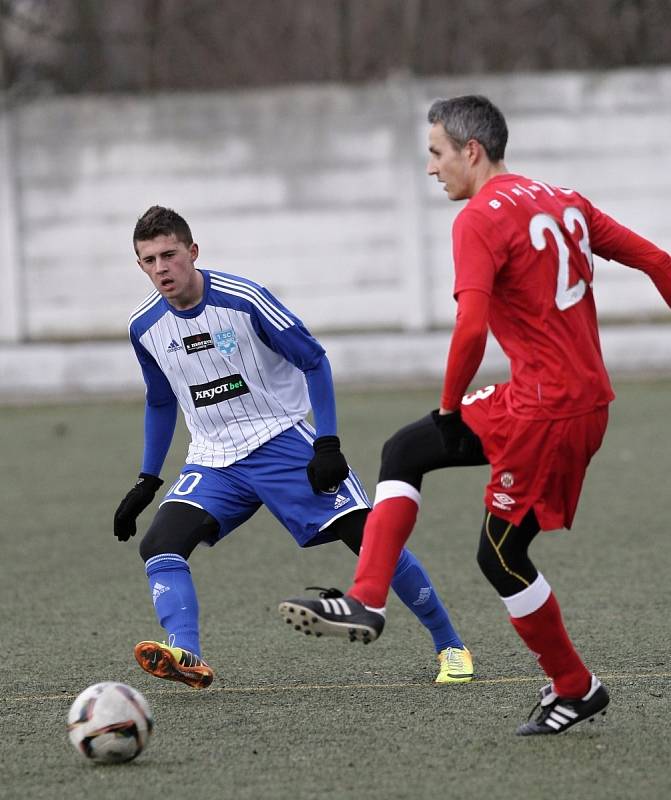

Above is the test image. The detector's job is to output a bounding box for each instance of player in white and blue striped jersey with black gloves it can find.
[114,206,468,688]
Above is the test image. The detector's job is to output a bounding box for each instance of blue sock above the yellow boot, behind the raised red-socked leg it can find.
[391,548,464,653]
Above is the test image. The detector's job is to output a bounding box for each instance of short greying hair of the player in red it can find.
[428,94,508,161]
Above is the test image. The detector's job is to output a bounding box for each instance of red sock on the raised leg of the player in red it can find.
[347,497,419,608]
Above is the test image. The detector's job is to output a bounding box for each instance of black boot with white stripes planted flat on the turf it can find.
[517,675,610,736]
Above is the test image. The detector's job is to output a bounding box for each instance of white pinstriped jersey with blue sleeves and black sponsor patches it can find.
[129,269,324,467]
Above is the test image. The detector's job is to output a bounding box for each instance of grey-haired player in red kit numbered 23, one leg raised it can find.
[280,96,671,736]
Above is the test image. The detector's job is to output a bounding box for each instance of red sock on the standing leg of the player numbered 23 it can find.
[510,593,592,697]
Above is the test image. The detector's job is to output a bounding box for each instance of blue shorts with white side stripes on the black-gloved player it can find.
[161,422,370,547]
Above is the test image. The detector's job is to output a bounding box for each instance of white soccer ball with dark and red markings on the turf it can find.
[67,681,154,764]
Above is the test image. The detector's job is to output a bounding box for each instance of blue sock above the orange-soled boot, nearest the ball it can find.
[145,553,200,656]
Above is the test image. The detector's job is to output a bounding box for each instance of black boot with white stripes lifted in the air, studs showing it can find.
[279,586,384,644]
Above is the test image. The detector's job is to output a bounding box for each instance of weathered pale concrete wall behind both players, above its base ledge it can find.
[0,69,671,394]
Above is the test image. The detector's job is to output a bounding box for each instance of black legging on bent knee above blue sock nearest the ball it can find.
[139,503,219,561]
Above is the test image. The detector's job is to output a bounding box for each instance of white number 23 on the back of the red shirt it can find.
[529,206,594,311]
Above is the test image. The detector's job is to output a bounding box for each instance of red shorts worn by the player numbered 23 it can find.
[461,383,608,531]
